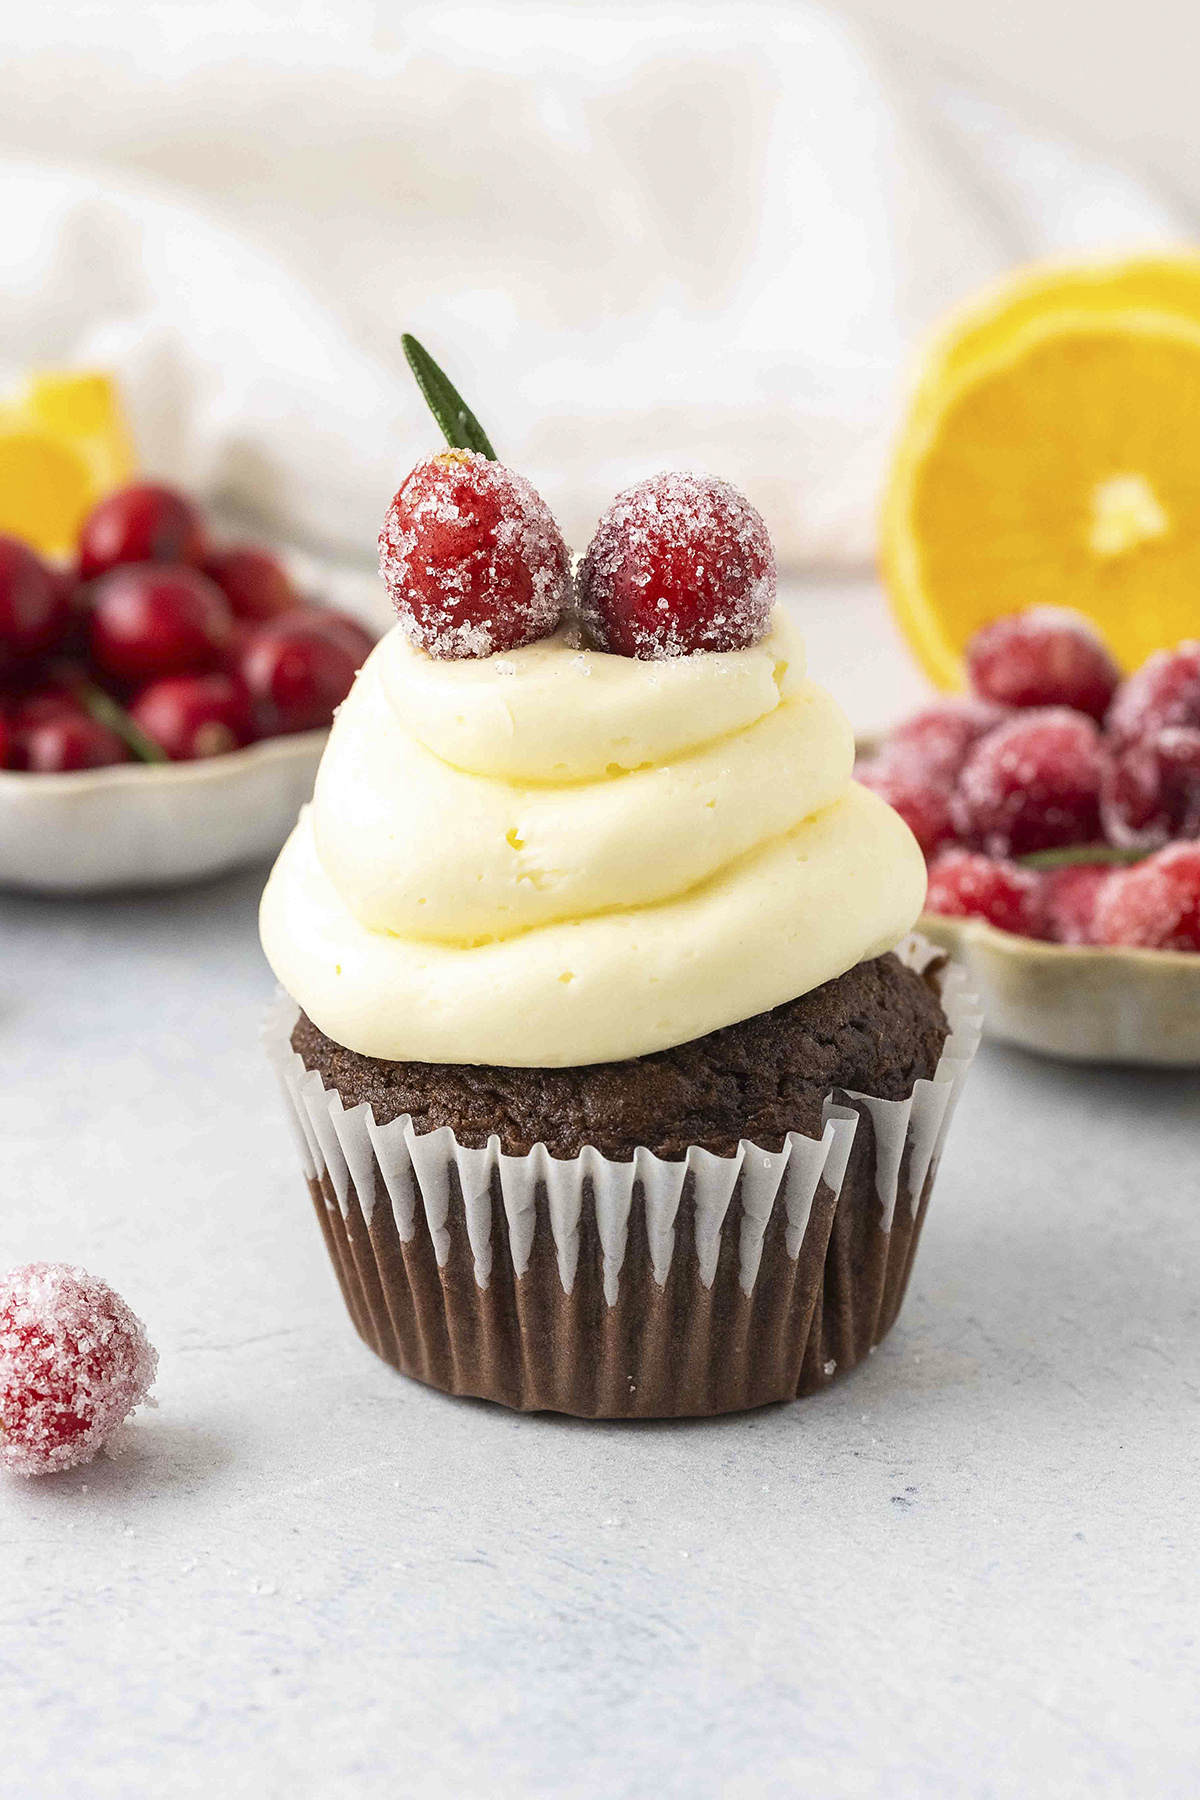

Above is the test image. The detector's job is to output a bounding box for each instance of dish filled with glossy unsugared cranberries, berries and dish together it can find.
[0,481,376,893]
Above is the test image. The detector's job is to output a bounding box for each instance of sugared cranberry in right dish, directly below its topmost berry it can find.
[950,706,1106,857]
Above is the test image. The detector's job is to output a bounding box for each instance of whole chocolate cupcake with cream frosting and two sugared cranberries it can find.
[261,354,979,1417]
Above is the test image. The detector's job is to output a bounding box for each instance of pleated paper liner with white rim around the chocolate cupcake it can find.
[264,936,981,1418]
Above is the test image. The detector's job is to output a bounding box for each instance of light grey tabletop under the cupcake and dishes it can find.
[0,583,1200,1800]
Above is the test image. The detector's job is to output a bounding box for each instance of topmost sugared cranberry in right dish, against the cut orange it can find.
[966,607,1121,718]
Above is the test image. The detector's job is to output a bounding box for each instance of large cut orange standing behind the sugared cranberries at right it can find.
[882,256,1200,688]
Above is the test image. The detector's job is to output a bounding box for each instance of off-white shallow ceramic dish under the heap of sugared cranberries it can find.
[918,913,1200,1067]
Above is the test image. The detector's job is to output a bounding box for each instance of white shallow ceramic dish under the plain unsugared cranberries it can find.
[0,538,392,893]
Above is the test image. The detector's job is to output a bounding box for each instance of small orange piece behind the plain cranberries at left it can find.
[0,373,137,556]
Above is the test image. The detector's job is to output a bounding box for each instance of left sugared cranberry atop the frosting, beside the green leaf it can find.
[380,450,570,659]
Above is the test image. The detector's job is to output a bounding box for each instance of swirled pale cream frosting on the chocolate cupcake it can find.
[261,608,925,1067]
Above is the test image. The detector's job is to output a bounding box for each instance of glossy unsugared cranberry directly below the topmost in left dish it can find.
[88,565,232,682]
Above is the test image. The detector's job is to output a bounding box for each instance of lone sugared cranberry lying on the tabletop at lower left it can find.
[0,1262,158,1474]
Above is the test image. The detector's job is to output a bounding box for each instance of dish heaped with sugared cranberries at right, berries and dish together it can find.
[856,607,1200,1066]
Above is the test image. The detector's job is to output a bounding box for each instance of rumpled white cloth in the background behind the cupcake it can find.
[0,0,1187,565]
